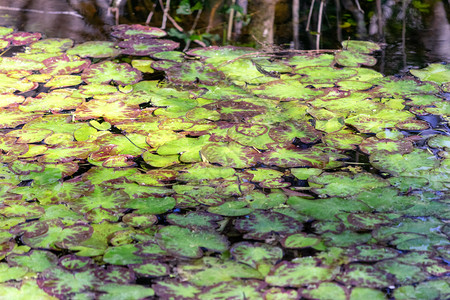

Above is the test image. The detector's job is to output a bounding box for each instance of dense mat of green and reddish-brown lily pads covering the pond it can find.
[0,25,450,299]
